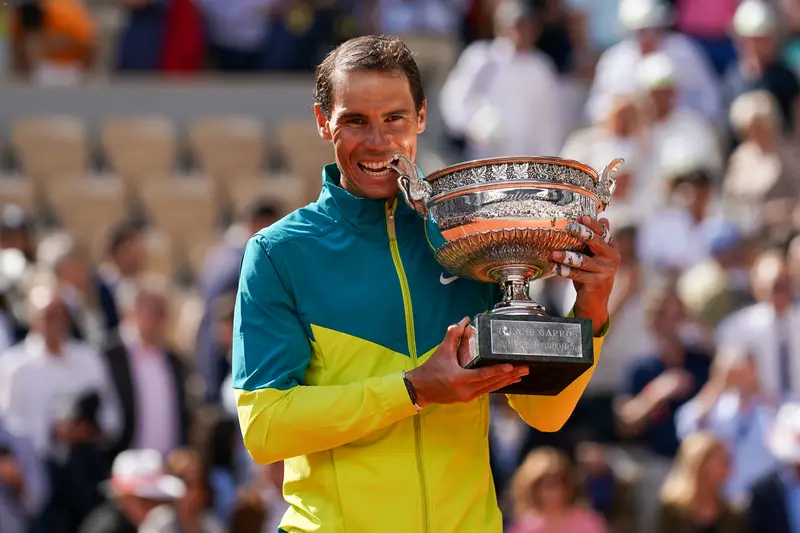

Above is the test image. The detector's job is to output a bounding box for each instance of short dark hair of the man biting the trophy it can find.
[314,35,425,117]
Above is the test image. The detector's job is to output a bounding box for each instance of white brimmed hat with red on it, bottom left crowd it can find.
[102,450,186,501]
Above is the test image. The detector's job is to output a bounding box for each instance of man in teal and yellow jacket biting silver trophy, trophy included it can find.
[232,32,620,533]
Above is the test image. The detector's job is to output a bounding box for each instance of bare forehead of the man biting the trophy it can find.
[332,71,414,114]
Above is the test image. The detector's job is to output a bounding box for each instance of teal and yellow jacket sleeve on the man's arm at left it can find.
[232,236,416,464]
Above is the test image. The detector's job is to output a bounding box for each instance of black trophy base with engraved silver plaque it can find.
[466,311,594,396]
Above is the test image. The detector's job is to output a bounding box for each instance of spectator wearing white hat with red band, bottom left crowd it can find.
[79,450,186,533]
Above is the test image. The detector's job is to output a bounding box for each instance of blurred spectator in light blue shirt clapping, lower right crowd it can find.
[675,346,778,505]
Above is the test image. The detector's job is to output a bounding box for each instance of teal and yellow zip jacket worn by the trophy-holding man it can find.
[233,165,602,533]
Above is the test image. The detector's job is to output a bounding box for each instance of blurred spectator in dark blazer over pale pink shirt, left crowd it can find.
[105,277,190,456]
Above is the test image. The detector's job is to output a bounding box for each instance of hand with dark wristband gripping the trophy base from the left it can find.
[406,318,529,407]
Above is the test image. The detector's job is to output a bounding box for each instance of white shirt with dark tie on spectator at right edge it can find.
[717,303,800,397]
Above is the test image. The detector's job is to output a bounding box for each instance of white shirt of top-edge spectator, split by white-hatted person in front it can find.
[586,33,723,124]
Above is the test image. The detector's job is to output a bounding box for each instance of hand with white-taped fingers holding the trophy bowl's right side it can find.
[550,216,620,335]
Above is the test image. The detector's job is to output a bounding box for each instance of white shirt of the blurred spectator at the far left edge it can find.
[0,334,120,455]
